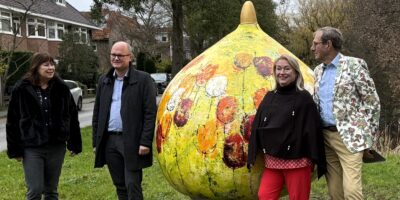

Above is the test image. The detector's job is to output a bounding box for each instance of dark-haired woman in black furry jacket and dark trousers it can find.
[6,53,82,199]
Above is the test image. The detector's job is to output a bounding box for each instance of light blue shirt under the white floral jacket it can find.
[319,54,339,126]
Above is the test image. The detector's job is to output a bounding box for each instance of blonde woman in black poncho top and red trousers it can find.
[248,55,326,200]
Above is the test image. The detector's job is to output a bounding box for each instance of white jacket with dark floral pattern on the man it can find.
[314,54,380,153]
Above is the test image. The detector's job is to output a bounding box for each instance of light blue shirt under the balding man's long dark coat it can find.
[108,71,128,132]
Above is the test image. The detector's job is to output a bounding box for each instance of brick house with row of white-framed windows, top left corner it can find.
[0,0,100,58]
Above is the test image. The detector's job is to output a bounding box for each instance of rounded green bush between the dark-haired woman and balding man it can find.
[58,34,98,87]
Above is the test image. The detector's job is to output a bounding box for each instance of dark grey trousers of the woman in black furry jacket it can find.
[22,143,66,200]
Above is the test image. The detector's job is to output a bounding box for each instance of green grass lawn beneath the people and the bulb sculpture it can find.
[0,128,400,200]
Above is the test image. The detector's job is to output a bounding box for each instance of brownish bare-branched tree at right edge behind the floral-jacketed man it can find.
[344,0,400,126]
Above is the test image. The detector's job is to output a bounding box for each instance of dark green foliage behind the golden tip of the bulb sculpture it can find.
[184,0,277,55]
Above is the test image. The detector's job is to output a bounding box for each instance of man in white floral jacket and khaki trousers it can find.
[311,27,380,200]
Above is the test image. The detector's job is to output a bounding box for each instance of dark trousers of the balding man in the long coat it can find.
[105,135,143,200]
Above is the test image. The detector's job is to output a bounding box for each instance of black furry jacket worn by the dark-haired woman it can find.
[6,77,82,158]
